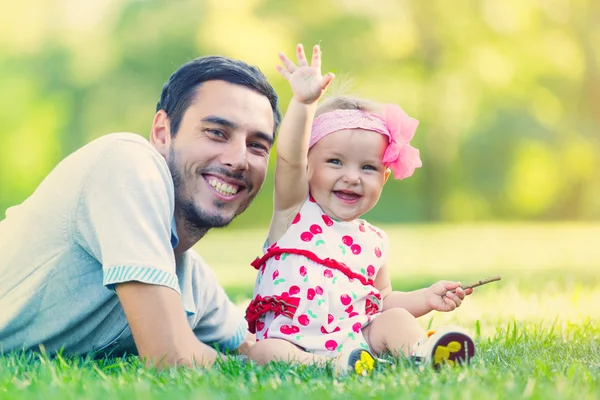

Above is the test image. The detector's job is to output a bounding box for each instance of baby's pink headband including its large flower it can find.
[309,104,422,179]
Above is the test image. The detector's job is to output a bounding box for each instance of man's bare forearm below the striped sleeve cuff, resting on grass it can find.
[116,282,217,368]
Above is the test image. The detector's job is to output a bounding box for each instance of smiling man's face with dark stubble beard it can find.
[166,81,274,229]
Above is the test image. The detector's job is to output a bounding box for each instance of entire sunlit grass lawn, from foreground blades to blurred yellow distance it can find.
[0,225,600,399]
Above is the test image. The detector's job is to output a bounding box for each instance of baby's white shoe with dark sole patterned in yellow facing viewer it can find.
[412,326,475,369]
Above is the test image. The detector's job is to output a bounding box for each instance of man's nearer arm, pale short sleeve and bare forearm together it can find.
[73,139,209,366]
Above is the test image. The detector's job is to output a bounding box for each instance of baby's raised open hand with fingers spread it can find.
[277,44,334,104]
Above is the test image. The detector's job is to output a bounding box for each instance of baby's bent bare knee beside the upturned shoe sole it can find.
[362,308,426,357]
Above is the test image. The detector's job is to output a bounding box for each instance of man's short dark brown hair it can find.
[156,56,281,136]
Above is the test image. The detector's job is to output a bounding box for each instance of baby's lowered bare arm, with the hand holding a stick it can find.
[375,266,473,318]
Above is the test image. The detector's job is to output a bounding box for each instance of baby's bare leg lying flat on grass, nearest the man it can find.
[248,339,332,367]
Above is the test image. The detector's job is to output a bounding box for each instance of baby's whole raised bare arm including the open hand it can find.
[269,44,333,243]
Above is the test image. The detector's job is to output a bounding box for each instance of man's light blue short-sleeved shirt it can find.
[0,133,247,354]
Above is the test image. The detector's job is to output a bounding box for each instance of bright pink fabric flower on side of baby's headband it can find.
[383,104,423,179]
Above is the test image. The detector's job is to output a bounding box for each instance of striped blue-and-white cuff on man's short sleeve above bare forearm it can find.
[103,265,180,293]
